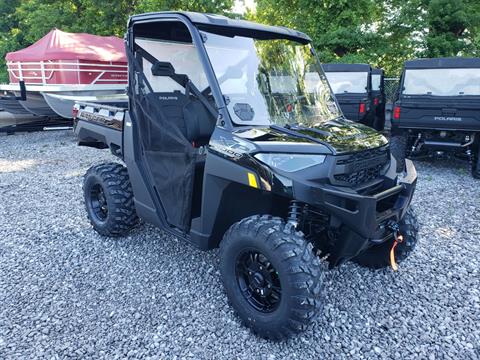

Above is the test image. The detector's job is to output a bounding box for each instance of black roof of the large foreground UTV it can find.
[128,11,312,44]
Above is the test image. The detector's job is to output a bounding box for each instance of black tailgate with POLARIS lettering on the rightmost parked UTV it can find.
[392,97,480,131]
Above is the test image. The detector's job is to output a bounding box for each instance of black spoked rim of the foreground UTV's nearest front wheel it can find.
[235,250,282,313]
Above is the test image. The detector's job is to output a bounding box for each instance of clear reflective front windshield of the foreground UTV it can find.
[205,33,341,126]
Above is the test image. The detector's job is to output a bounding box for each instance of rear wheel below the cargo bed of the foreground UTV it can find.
[83,163,138,236]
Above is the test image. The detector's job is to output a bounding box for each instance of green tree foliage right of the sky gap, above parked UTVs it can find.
[248,0,480,76]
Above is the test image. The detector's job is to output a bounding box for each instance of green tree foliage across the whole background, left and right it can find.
[0,0,480,82]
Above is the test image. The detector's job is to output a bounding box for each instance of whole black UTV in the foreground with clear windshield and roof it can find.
[74,12,418,339]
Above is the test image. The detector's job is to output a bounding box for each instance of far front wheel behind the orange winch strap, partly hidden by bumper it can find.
[352,208,419,269]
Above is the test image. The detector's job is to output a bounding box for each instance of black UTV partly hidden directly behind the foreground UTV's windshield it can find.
[322,64,375,127]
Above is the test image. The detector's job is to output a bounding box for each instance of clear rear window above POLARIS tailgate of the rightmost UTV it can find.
[402,69,480,96]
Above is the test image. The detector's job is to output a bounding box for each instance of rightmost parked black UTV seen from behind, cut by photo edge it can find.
[391,57,480,178]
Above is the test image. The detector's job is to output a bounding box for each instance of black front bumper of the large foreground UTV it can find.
[294,160,417,261]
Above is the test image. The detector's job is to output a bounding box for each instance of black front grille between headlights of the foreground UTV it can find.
[334,146,390,186]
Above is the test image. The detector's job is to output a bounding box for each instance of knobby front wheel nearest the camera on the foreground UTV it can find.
[220,216,323,340]
